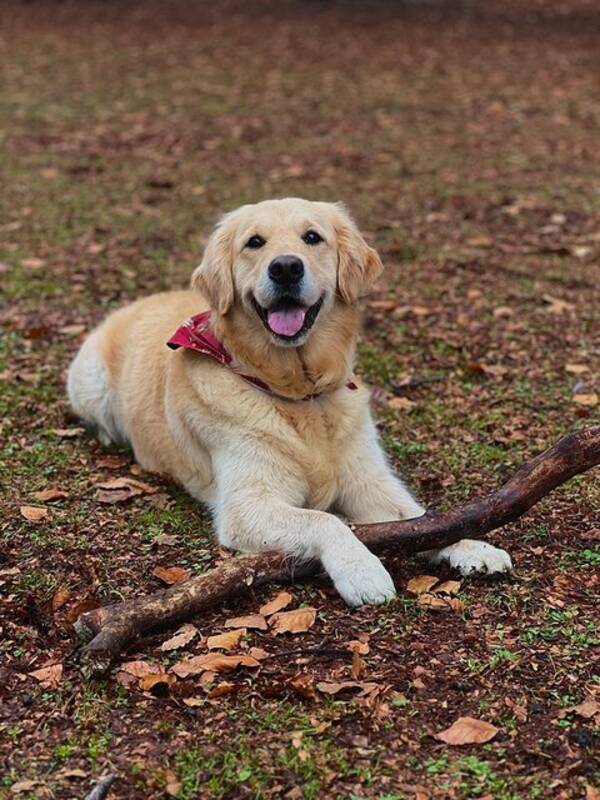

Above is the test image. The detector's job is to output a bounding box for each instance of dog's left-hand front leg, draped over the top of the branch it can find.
[213,444,395,606]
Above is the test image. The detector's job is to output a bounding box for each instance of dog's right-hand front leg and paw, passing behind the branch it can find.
[337,420,513,575]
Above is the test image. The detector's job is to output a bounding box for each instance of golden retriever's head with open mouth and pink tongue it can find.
[192,198,382,347]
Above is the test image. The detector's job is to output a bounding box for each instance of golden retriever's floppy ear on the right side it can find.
[334,203,383,305]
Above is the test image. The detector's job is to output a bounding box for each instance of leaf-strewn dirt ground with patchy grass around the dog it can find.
[0,0,600,800]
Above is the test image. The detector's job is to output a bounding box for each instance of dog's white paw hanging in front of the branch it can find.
[321,542,396,606]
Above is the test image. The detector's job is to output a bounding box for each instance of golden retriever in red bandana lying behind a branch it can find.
[68,198,512,606]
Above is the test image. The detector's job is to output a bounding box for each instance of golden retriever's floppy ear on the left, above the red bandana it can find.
[191,217,234,315]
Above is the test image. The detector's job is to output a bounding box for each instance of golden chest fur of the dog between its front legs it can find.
[279,401,358,509]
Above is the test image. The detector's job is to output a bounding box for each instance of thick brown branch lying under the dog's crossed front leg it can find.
[75,427,600,673]
